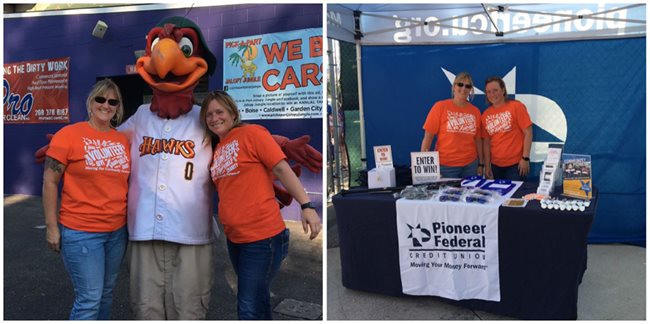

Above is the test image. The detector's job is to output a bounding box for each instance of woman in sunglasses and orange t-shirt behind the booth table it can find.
[420,72,483,178]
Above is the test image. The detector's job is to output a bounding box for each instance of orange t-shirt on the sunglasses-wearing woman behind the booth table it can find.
[422,99,481,167]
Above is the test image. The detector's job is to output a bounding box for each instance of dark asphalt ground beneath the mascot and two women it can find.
[4,195,323,320]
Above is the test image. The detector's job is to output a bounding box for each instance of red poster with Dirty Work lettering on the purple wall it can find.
[2,57,70,124]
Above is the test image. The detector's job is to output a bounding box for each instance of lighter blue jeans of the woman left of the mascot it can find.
[59,224,127,320]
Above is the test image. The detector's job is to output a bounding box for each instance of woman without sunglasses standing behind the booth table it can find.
[482,77,533,181]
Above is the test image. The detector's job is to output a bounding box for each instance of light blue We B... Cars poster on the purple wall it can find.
[223,28,323,120]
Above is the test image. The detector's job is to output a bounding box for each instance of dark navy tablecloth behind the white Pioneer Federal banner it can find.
[332,183,598,319]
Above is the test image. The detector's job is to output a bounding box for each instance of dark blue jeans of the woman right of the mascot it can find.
[228,229,289,320]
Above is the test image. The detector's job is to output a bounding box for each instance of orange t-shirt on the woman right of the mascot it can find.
[210,125,286,243]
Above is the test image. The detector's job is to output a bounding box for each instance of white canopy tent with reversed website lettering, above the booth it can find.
[327,3,646,169]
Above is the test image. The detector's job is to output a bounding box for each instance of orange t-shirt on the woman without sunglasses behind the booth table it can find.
[482,100,533,167]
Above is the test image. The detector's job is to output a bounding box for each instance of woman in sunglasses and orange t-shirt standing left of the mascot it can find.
[43,79,131,320]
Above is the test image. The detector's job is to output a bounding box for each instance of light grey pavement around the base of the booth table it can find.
[327,204,646,320]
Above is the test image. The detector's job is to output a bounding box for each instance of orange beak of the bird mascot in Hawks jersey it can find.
[135,38,208,92]
